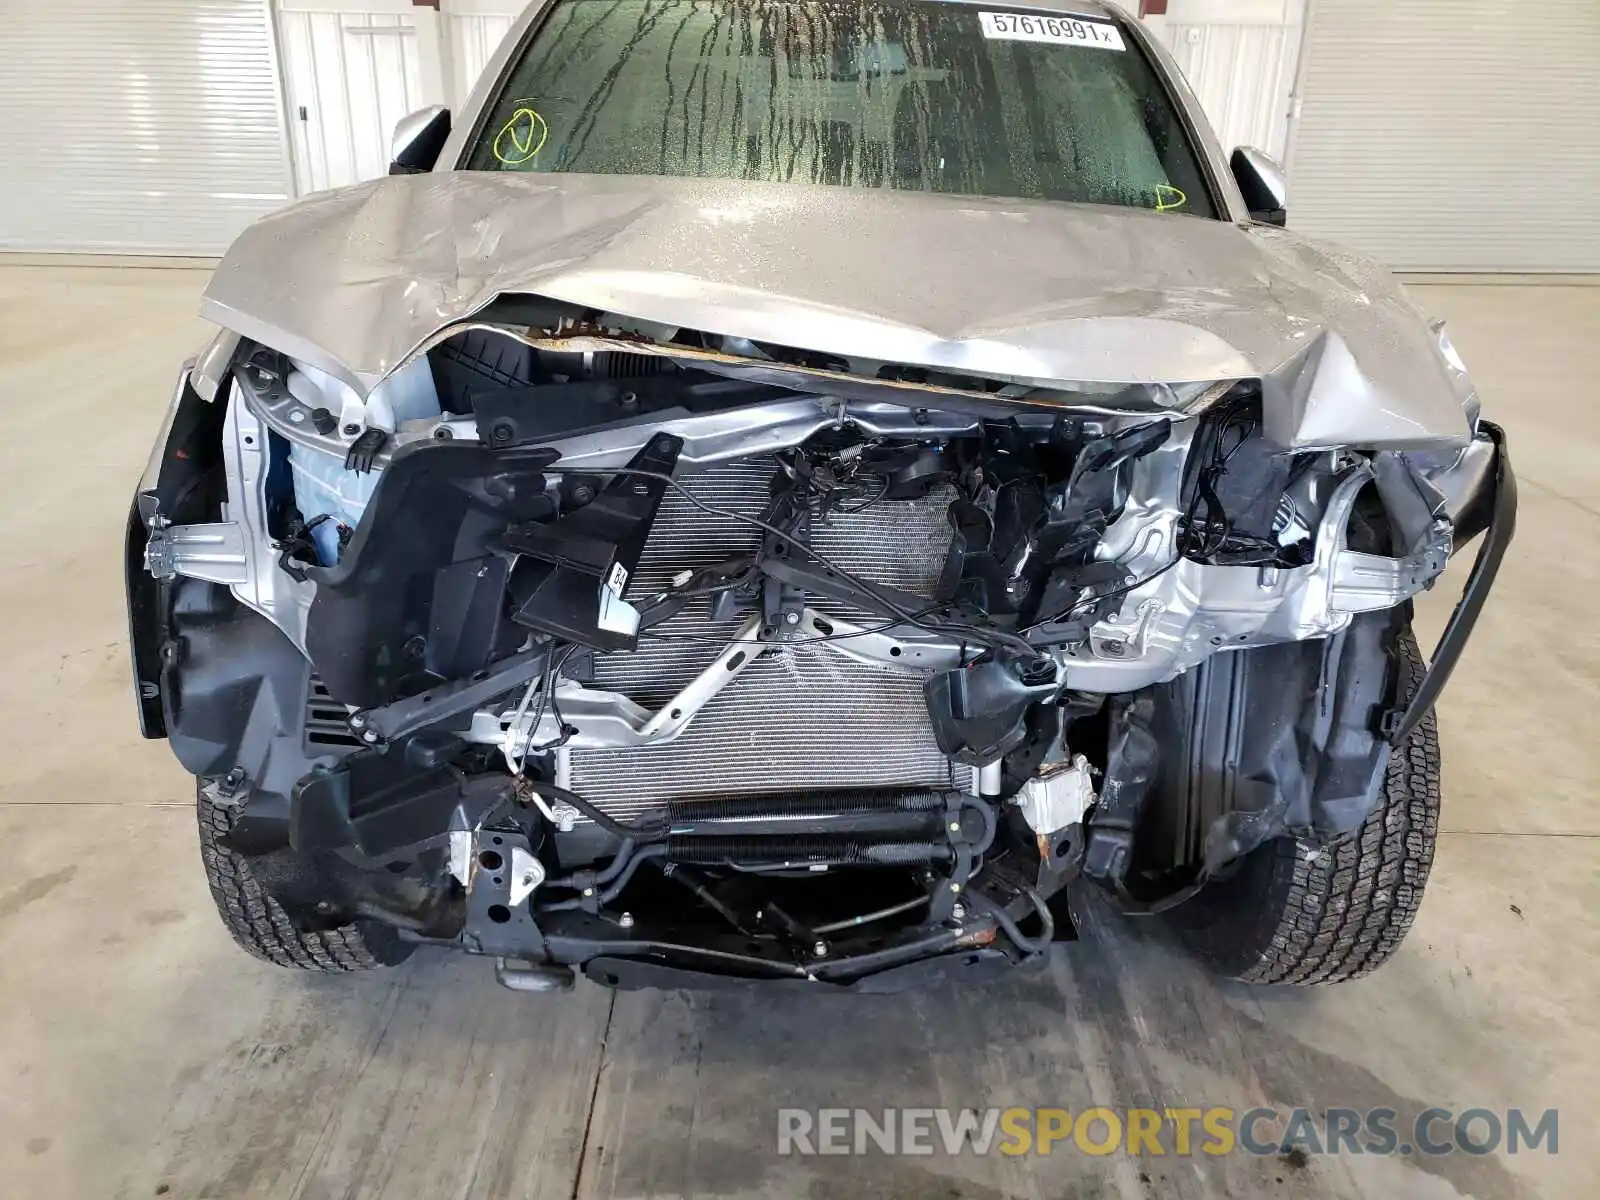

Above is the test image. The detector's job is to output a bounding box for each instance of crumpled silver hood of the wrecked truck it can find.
[202,171,1470,446]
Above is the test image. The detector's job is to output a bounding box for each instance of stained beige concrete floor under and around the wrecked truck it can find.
[0,267,1600,1200]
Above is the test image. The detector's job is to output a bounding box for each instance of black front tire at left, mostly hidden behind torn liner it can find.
[195,790,414,971]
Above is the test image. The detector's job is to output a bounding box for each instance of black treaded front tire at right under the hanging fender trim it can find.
[1170,626,1440,986]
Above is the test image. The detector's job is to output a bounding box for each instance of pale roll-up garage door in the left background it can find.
[0,0,291,254]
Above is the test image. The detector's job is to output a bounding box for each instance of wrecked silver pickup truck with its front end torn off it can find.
[126,0,1515,990]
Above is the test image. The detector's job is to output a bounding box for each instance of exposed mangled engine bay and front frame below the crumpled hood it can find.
[121,315,1497,987]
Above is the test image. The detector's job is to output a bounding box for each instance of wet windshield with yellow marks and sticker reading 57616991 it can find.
[467,0,1214,216]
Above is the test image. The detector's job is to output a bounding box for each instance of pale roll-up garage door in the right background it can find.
[1290,0,1600,272]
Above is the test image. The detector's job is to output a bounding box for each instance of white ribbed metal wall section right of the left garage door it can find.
[278,0,424,194]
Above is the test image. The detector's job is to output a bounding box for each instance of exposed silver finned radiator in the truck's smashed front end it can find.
[558,458,970,818]
